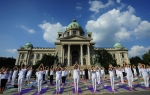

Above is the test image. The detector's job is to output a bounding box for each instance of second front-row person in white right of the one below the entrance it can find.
[108,64,115,92]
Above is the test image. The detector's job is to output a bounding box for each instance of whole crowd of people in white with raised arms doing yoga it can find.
[0,62,150,95]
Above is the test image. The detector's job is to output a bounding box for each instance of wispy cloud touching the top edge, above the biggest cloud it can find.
[88,0,114,13]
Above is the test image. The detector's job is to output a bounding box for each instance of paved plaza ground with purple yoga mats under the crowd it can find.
[3,75,150,95]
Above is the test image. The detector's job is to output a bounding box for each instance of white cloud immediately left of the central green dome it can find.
[38,21,66,43]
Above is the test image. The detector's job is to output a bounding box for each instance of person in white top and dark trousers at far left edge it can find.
[0,68,10,94]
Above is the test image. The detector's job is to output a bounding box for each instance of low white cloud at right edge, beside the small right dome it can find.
[129,45,150,57]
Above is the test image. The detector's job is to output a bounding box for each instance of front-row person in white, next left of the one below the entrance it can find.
[56,66,62,94]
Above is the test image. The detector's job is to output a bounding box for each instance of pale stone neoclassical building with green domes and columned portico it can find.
[16,20,130,66]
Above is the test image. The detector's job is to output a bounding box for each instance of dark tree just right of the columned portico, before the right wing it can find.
[97,49,117,73]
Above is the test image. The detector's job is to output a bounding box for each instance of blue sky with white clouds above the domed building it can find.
[0,0,150,58]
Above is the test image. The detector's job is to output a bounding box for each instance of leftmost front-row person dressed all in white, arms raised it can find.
[18,64,27,94]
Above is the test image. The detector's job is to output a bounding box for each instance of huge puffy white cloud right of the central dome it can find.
[85,6,150,46]
